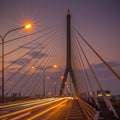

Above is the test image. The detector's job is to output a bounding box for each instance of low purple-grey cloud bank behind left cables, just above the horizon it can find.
[5,66,63,95]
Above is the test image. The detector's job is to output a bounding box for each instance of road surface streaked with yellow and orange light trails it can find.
[0,97,85,120]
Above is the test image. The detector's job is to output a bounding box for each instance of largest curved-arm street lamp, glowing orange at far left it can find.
[0,23,32,99]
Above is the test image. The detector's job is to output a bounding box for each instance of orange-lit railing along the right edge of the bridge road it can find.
[76,98,99,120]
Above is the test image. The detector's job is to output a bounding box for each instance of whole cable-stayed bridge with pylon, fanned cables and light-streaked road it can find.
[0,10,120,120]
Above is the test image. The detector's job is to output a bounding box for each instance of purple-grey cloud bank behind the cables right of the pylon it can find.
[75,61,120,81]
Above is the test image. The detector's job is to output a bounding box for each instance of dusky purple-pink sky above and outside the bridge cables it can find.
[0,0,120,94]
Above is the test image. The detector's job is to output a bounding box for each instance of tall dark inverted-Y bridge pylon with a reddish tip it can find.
[60,10,79,96]
